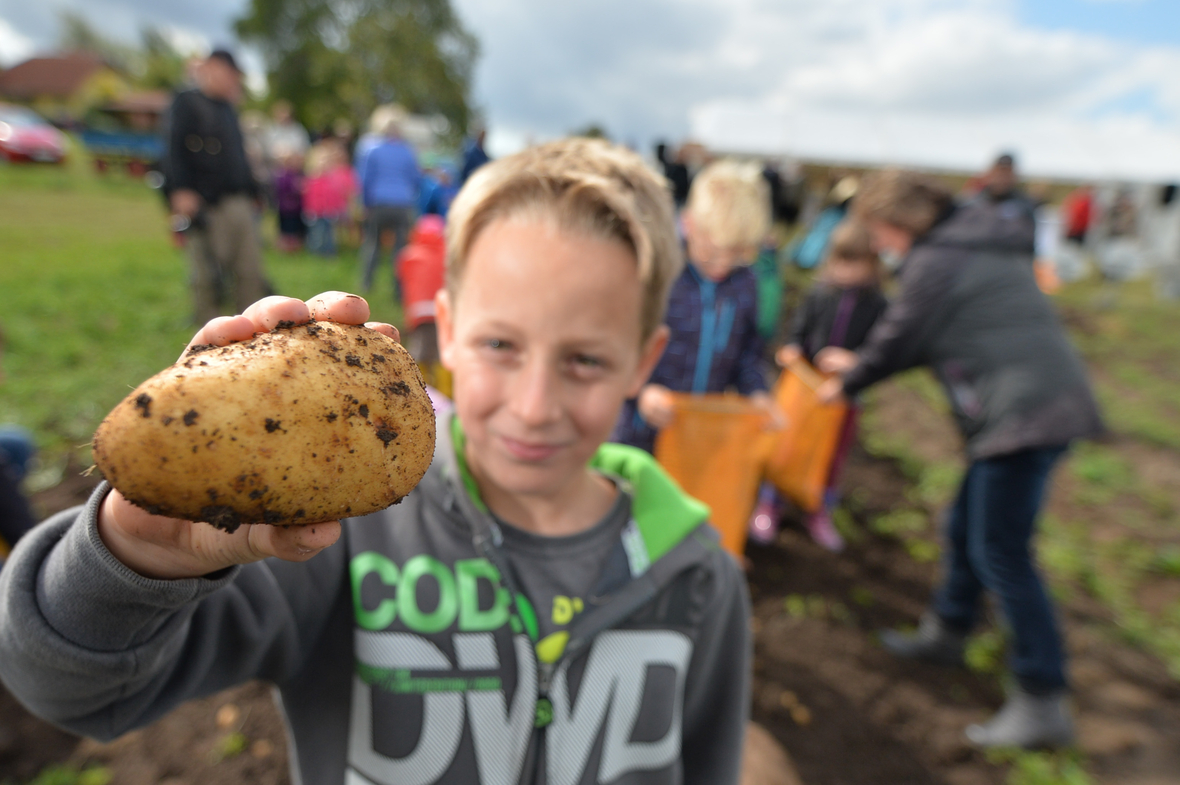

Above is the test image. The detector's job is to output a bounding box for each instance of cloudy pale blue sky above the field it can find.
[0,0,1180,182]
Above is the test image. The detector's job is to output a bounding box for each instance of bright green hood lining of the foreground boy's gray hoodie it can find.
[451,416,709,562]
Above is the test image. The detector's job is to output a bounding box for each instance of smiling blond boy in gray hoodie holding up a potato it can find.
[0,139,749,785]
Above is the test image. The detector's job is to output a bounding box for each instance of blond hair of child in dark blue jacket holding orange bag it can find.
[688,158,771,248]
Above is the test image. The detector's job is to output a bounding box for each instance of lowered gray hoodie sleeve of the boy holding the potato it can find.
[681,550,752,785]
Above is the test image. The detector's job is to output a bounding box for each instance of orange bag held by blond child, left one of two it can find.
[655,393,767,557]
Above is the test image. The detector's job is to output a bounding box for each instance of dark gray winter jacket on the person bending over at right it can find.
[844,199,1102,460]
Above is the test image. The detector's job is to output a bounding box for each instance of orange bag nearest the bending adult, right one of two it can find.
[765,360,848,512]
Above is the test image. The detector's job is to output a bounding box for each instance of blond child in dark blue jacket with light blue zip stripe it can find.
[614,161,771,452]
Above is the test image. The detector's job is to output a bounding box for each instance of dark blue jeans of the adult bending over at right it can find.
[933,446,1066,694]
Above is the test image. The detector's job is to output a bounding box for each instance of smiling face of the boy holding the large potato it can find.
[438,212,667,499]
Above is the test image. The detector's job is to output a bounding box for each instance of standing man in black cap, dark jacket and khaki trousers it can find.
[164,50,270,325]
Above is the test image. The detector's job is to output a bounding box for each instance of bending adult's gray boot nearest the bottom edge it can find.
[965,688,1074,750]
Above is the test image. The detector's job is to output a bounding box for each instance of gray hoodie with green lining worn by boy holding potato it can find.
[0,413,750,785]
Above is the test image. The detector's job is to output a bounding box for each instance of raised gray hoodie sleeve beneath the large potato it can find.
[0,485,345,739]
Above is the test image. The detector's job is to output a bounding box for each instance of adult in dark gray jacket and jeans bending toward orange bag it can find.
[818,171,1102,747]
